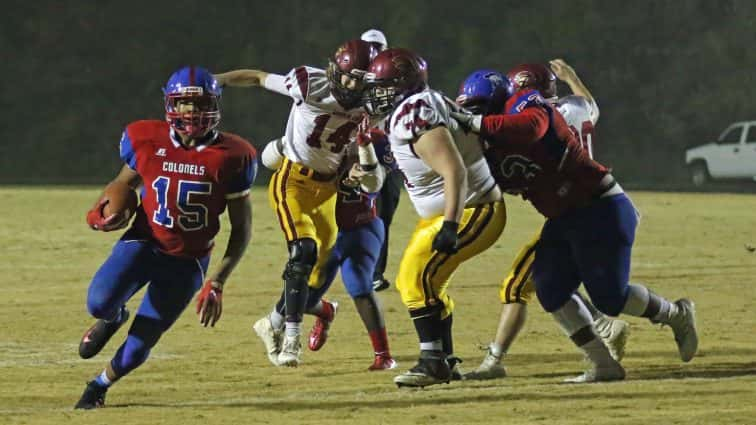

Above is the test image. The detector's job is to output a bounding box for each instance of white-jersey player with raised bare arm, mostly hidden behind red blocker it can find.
[457,59,629,379]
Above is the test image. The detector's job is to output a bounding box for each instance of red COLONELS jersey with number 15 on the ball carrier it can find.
[121,120,257,258]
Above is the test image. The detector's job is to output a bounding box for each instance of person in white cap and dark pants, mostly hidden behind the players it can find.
[360,29,402,291]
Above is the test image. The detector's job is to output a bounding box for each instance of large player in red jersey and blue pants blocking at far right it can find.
[453,68,698,383]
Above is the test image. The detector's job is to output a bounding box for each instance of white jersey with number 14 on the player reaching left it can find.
[283,66,362,174]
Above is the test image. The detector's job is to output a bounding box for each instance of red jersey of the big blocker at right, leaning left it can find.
[480,90,609,218]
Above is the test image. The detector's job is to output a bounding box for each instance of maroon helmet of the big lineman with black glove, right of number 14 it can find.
[364,48,428,115]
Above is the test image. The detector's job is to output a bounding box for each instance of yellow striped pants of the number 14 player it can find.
[268,158,338,288]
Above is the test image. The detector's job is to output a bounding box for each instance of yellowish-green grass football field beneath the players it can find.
[0,188,756,425]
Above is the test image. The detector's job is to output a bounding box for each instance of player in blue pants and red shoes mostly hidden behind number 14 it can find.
[262,115,397,370]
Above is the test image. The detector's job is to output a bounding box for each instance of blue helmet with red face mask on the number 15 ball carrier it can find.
[163,66,221,138]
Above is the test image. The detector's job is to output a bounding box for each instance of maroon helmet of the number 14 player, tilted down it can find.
[326,39,378,109]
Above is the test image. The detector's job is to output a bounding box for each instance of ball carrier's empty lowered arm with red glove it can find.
[197,196,252,326]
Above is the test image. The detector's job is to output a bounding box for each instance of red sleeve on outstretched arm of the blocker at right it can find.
[480,107,549,143]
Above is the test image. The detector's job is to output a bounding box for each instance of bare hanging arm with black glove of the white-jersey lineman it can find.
[413,126,467,254]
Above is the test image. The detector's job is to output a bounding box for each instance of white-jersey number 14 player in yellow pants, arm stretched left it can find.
[216,40,376,367]
